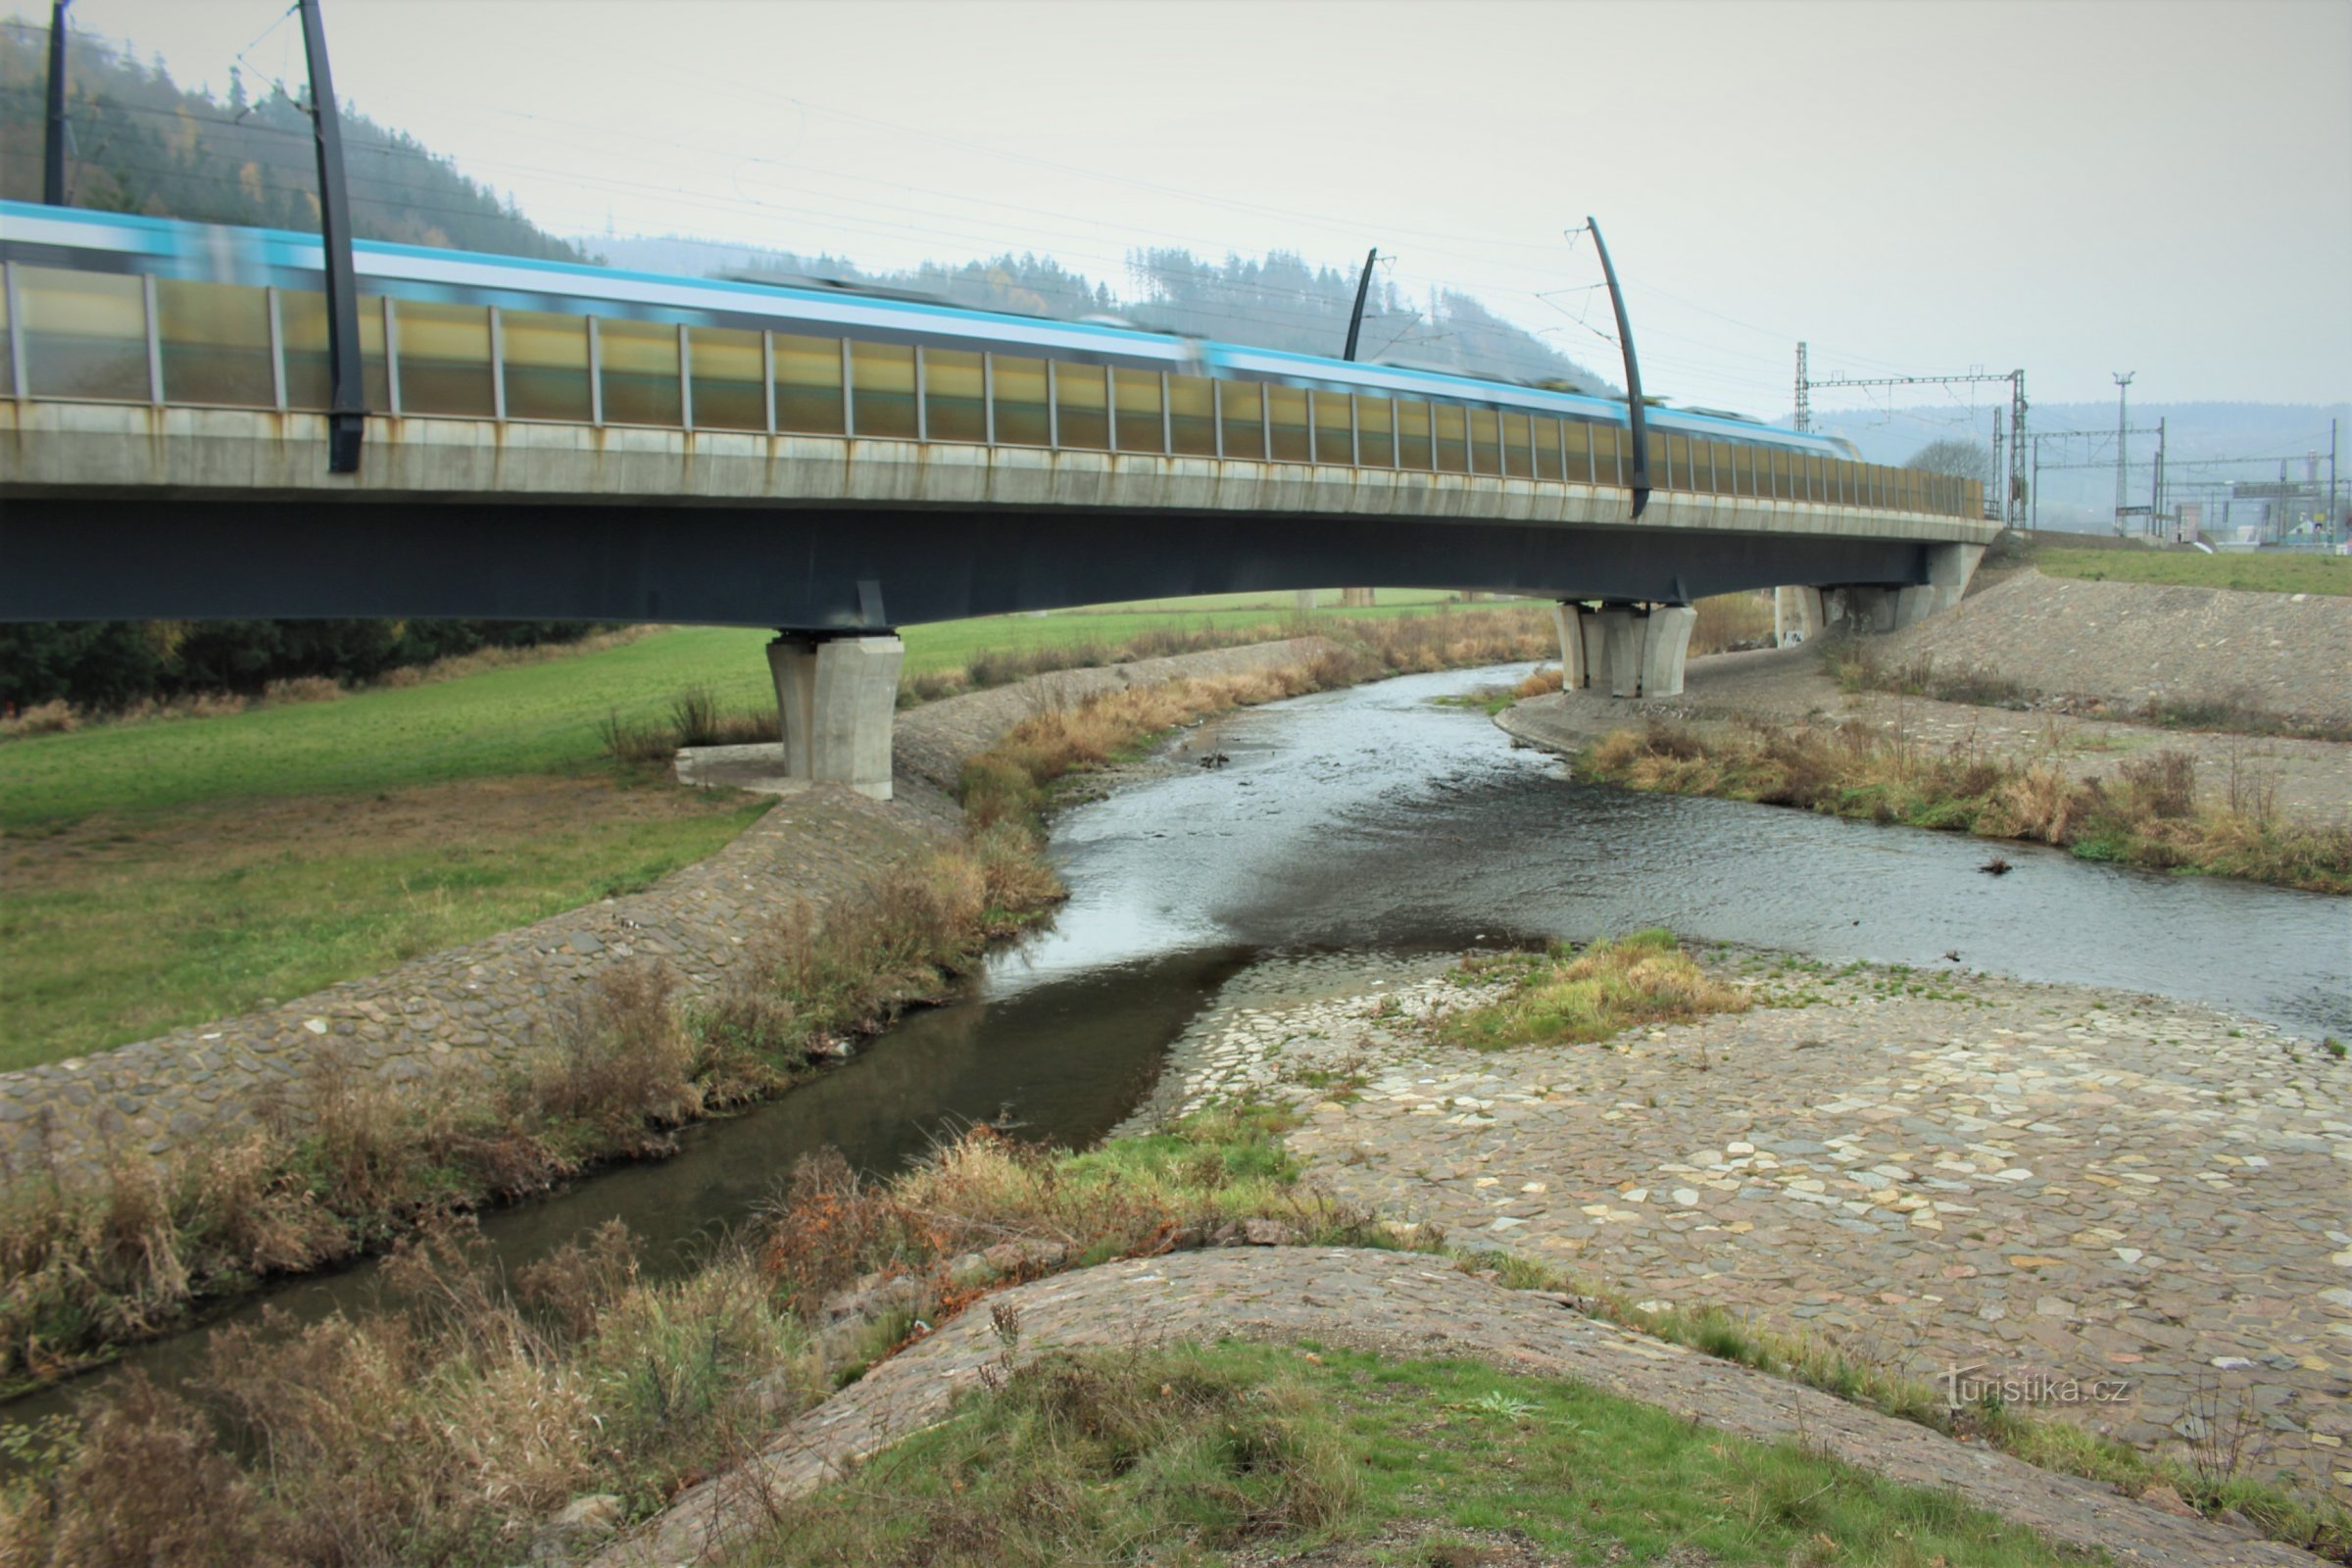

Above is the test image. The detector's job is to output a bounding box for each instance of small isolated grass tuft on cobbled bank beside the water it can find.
[1437,929,1747,1051]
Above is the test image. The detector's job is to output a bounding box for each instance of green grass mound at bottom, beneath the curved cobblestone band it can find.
[766,1340,2100,1568]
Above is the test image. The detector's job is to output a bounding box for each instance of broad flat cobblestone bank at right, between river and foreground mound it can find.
[1109,956,2352,1499]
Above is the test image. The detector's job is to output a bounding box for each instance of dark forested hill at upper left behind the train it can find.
[0,19,590,261]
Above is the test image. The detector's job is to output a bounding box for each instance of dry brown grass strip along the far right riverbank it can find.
[1578,721,2352,894]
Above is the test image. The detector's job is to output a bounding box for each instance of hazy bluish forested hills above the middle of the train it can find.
[593,235,1616,390]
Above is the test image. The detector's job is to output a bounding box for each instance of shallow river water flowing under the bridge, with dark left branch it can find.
[7,667,2352,1420]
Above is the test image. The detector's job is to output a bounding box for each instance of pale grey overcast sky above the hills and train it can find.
[50,0,2352,414]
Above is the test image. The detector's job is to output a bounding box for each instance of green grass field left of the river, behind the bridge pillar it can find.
[0,595,1524,1069]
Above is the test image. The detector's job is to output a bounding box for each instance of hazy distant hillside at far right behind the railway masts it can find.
[1813,402,2352,531]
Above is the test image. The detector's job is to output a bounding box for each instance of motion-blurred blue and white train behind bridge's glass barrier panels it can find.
[0,202,1856,496]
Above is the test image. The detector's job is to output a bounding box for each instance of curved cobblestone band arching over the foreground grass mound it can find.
[595,1246,2317,1568]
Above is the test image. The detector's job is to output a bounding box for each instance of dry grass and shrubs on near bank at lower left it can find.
[0,1109,1371,1566]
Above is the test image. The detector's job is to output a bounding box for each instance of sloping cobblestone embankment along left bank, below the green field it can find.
[0,637,1331,1171]
